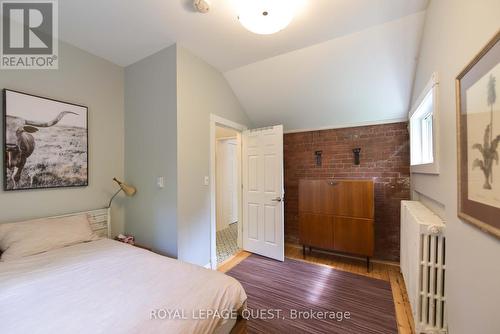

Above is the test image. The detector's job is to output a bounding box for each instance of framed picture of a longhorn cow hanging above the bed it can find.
[3,89,88,191]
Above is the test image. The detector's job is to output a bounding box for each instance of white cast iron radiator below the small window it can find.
[401,201,447,333]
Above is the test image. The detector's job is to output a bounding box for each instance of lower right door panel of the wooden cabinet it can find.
[333,217,374,256]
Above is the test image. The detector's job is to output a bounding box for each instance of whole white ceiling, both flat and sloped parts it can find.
[59,0,428,130]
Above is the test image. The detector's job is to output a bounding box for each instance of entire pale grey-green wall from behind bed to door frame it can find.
[0,39,250,265]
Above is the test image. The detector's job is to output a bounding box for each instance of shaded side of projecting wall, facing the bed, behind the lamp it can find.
[125,45,177,257]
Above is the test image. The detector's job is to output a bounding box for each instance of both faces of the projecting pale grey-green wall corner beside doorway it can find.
[125,45,249,265]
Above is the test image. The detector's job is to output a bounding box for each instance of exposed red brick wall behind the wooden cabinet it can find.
[284,123,410,261]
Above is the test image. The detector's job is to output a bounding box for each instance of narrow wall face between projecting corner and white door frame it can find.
[177,46,250,265]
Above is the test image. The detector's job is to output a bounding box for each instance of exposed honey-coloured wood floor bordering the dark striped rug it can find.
[218,244,415,334]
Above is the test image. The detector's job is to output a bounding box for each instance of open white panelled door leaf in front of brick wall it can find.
[242,125,285,261]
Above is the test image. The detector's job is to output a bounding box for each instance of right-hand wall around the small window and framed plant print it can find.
[412,0,500,334]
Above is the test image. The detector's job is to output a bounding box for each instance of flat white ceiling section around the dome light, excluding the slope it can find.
[59,0,428,72]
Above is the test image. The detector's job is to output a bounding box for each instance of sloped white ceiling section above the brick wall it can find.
[225,13,424,131]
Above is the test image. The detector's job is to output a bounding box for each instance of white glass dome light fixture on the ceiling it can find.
[235,0,304,35]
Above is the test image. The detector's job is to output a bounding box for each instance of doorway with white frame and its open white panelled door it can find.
[210,114,285,270]
